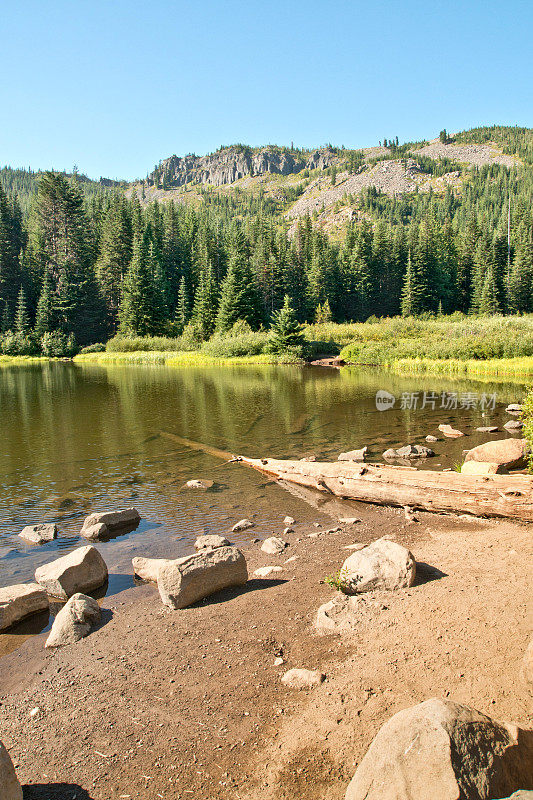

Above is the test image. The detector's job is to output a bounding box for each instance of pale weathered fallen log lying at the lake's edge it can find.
[240,456,533,522]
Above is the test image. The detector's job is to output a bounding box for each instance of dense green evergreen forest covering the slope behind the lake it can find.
[0,128,533,355]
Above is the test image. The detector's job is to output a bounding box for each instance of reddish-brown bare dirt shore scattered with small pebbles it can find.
[0,494,533,800]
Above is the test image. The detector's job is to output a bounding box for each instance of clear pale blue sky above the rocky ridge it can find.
[0,0,533,179]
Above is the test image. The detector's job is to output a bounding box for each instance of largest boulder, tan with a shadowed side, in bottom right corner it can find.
[345,698,533,800]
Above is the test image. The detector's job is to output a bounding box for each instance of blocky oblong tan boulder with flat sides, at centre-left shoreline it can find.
[157,547,248,608]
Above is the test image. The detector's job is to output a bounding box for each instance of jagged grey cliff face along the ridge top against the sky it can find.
[148,145,337,187]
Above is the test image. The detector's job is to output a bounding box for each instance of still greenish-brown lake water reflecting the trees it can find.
[0,363,523,593]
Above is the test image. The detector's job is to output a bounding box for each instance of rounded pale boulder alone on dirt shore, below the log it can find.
[340,539,416,594]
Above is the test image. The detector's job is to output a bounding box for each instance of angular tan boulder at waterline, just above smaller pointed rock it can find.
[35,544,108,600]
